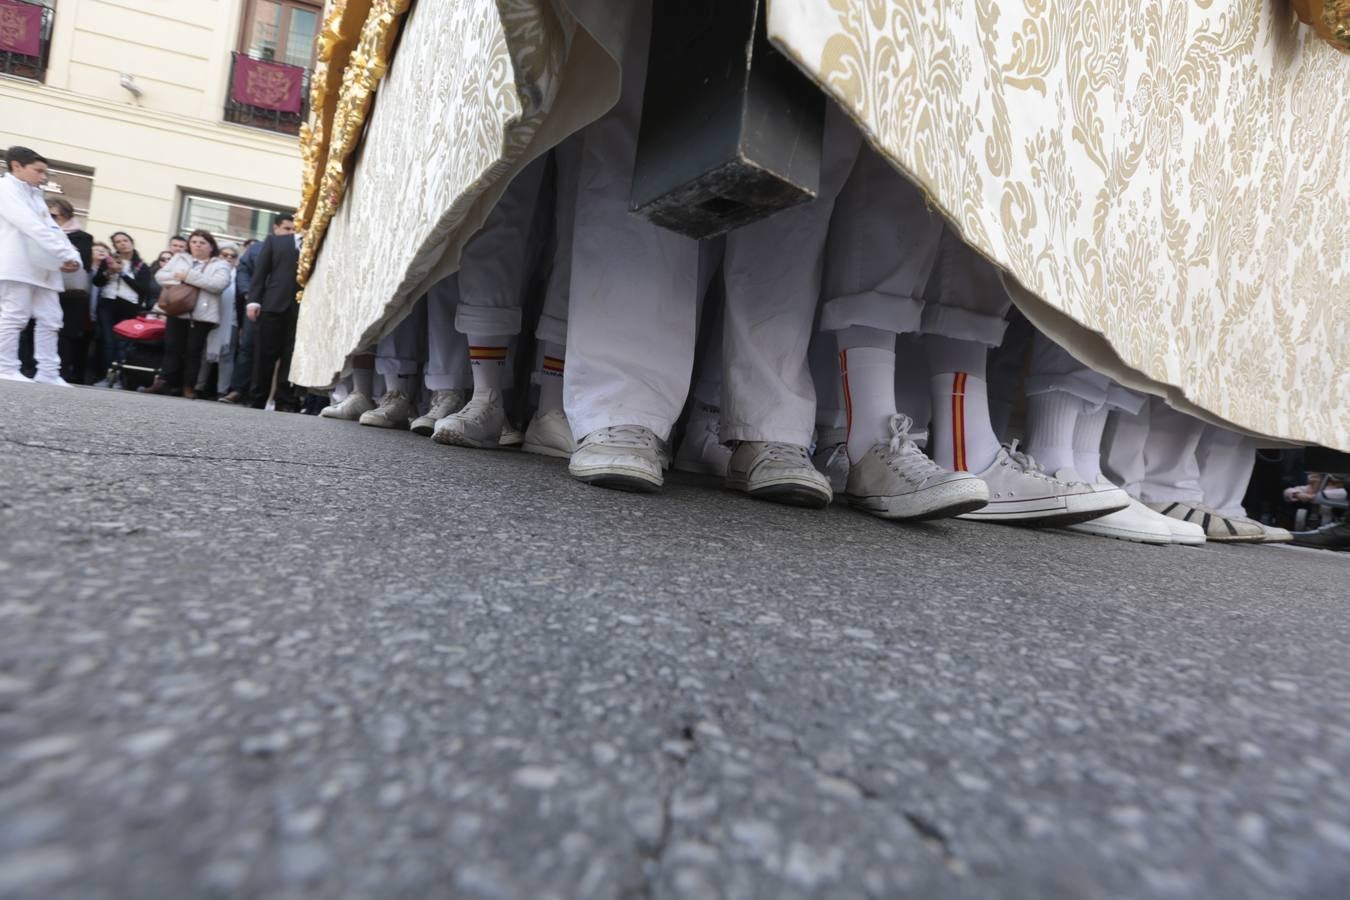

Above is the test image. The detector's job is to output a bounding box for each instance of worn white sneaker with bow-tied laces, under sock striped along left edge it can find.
[846,414,990,519]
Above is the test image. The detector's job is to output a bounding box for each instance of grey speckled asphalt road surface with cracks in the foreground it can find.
[0,383,1350,900]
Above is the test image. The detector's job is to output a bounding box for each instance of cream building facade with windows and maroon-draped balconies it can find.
[0,0,313,256]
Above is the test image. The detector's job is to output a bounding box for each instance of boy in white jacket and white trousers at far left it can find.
[0,147,81,386]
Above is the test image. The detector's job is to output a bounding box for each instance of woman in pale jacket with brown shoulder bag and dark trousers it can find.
[146,229,231,399]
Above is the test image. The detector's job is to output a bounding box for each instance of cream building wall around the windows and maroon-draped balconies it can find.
[0,0,300,256]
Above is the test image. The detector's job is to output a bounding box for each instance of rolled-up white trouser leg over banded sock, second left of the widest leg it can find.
[455,157,547,335]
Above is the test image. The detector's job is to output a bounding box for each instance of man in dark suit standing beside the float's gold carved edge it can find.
[247,215,300,413]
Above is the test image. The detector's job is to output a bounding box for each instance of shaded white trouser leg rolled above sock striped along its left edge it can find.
[821,146,942,335]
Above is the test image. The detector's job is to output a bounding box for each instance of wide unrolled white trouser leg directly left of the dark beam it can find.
[563,3,699,441]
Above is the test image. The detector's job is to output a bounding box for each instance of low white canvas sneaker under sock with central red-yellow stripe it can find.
[961,441,1130,528]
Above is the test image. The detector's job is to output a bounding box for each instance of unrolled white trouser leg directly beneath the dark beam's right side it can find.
[721,103,863,447]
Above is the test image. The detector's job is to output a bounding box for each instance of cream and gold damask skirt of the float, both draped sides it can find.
[293,0,1350,449]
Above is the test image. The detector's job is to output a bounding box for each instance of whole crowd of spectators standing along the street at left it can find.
[0,147,306,413]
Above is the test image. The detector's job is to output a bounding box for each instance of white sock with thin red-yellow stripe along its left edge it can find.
[836,325,895,463]
